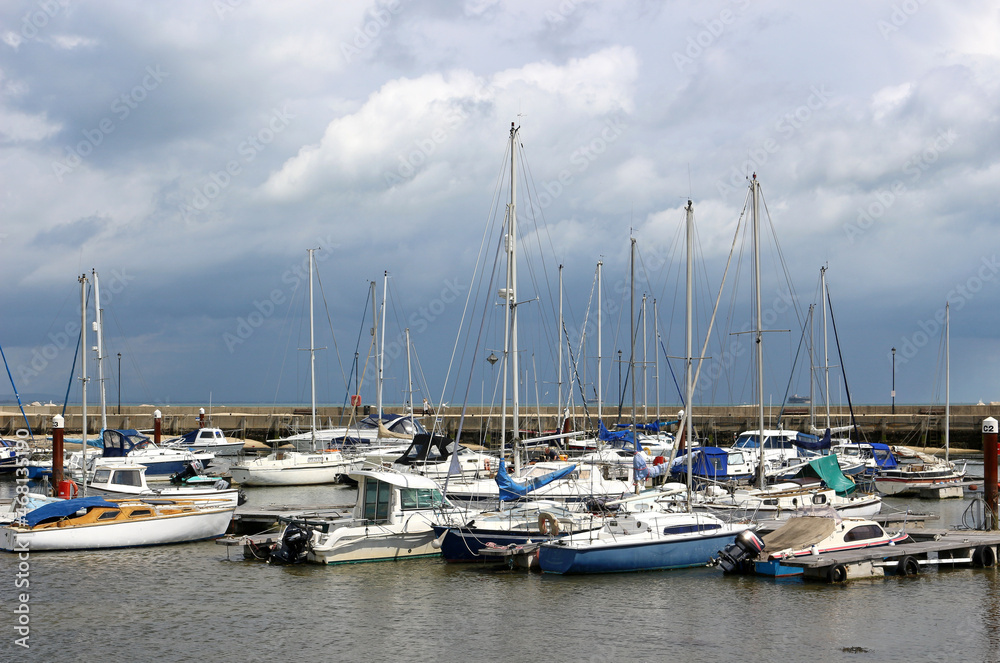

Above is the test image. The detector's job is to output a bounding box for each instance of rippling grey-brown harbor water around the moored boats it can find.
[0,478,1000,662]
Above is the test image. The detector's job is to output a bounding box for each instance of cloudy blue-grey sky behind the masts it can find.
[0,0,1000,416]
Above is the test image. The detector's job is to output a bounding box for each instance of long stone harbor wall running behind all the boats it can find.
[0,404,1000,449]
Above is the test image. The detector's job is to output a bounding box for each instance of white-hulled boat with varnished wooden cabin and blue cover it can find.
[0,497,236,553]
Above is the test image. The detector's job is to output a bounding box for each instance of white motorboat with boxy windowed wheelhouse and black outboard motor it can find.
[270,468,474,564]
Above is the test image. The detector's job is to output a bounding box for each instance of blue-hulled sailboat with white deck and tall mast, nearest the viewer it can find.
[538,201,749,574]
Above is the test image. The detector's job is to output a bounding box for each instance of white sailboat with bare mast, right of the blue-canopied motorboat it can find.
[230,249,353,486]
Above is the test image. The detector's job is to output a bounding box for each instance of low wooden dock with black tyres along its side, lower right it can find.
[781,529,1000,582]
